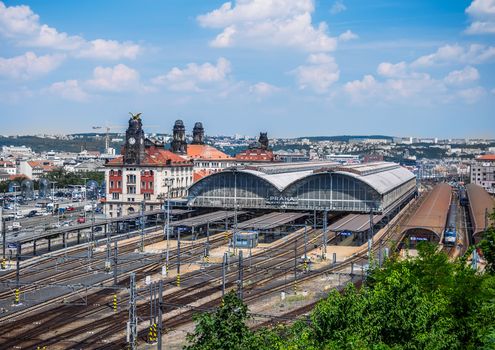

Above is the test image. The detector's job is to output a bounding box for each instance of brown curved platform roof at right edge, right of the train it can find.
[466,184,495,239]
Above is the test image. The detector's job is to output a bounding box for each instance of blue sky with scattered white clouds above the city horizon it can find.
[0,0,495,137]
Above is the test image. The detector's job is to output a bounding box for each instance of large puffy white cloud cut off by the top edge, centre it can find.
[197,0,337,52]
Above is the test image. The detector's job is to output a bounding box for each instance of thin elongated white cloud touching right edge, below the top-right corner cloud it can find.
[411,44,495,67]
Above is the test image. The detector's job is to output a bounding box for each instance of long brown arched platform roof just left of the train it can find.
[402,183,452,238]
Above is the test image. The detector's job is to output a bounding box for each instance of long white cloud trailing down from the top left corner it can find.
[0,2,141,60]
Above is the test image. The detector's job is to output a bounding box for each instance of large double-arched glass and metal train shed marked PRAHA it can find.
[188,161,416,214]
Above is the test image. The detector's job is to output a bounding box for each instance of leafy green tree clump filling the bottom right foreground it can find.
[187,244,495,350]
